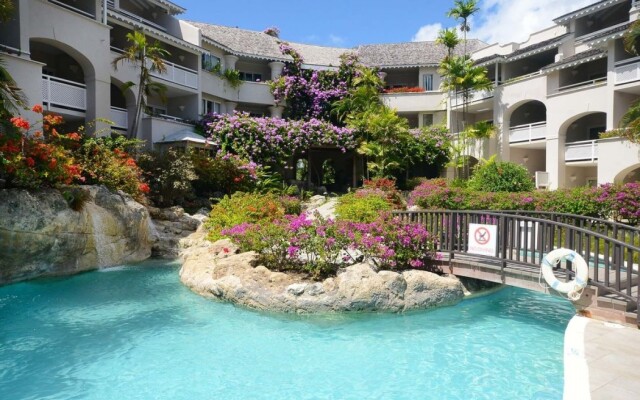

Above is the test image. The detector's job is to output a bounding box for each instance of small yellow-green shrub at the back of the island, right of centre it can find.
[336,189,393,222]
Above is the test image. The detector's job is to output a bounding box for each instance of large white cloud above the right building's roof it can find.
[468,0,595,44]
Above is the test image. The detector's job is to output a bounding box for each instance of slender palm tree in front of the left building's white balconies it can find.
[111,31,169,138]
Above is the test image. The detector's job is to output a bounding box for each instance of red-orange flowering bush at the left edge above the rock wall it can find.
[0,105,82,189]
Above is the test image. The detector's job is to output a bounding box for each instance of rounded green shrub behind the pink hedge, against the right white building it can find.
[468,159,535,192]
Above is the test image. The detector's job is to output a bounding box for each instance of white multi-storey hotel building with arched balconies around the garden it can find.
[0,0,640,189]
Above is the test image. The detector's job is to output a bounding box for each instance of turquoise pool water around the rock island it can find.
[0,263,573,400]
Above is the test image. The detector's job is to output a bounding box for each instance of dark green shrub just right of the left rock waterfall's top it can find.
[139,148,196,207]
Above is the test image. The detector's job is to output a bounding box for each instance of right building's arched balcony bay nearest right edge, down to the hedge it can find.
[560,112,607,188]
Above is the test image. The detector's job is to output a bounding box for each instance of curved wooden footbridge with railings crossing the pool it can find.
[395,211,640,327]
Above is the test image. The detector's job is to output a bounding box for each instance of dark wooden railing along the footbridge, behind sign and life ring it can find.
[394,211,640,322]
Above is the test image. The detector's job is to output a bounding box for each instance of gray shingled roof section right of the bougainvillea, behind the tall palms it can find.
[357,39,487,68]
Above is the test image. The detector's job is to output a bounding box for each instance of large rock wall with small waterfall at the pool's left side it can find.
[0,186,152,284]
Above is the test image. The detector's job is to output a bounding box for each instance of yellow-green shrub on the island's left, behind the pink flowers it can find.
[206,192,299,241]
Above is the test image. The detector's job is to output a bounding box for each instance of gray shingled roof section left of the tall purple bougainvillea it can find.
[187,21,289,61]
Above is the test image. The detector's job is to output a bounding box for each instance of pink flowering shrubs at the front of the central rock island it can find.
[222,214,435,278]
